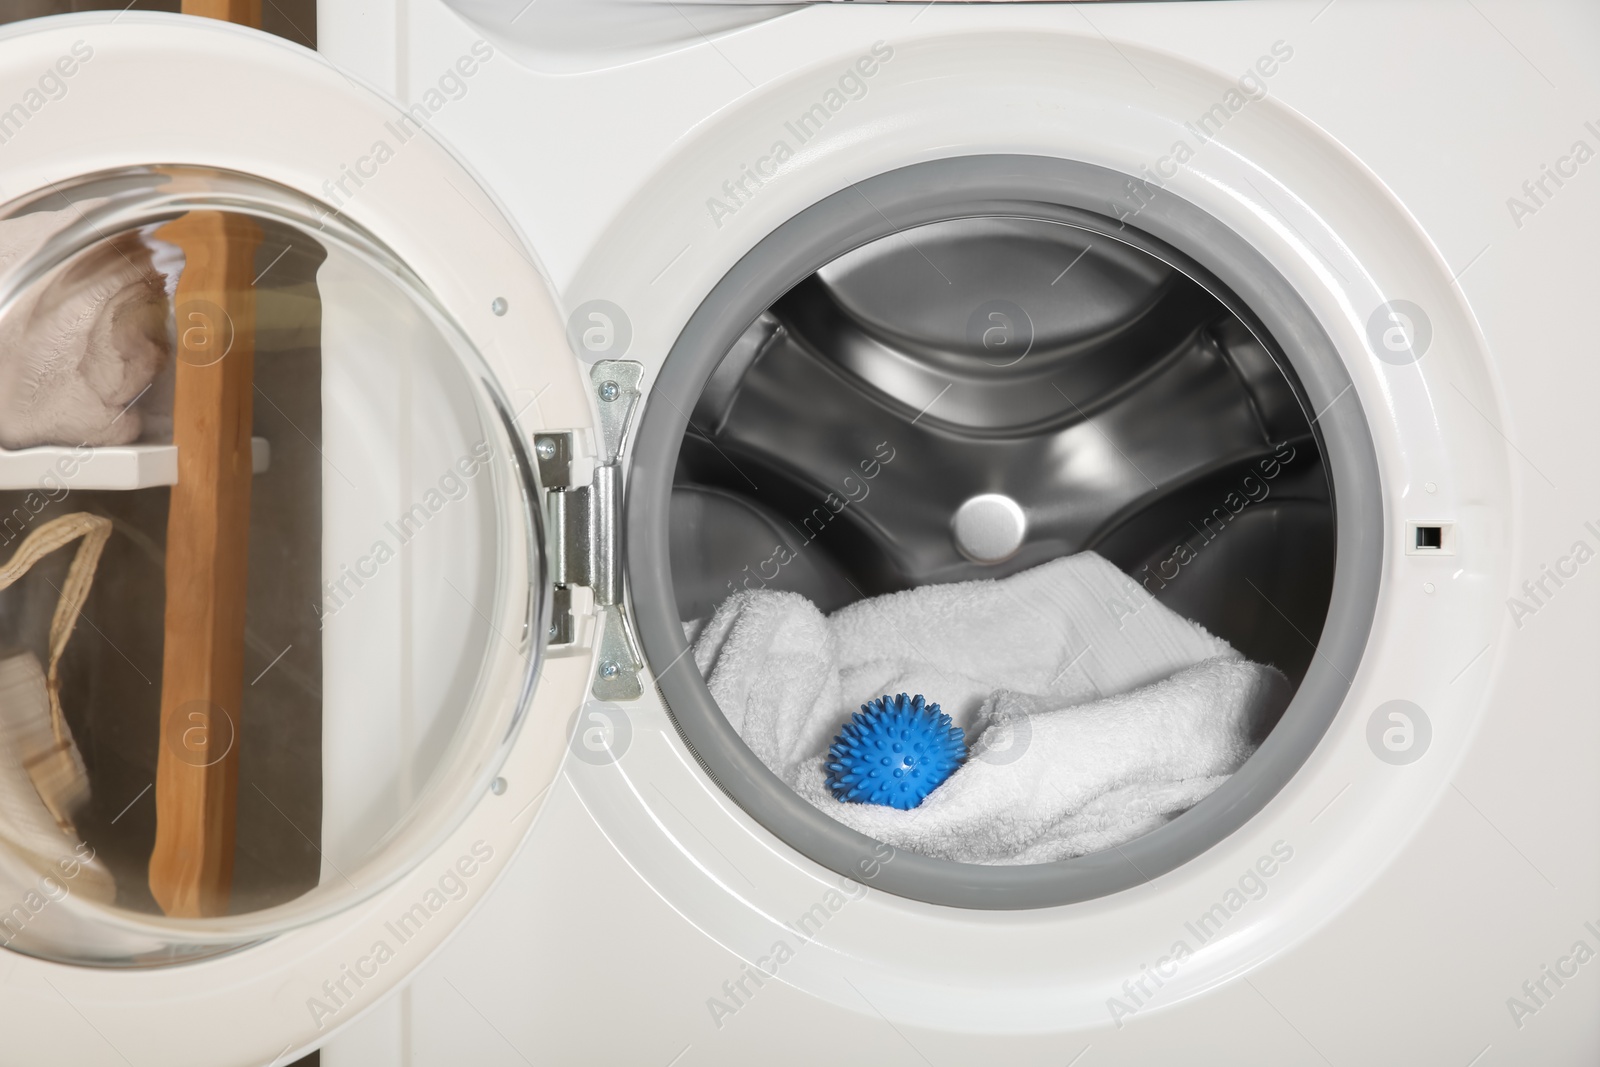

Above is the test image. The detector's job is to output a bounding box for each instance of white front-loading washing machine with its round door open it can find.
[0,0,1600,1067]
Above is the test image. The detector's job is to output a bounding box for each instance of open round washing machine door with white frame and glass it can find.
[0,14,601,1065]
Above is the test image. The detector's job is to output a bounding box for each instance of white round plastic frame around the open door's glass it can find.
[0,11,594,1067]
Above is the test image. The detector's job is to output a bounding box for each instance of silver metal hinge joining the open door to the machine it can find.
[533,360,645,701]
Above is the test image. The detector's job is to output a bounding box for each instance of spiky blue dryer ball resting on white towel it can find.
[827,693,966,811]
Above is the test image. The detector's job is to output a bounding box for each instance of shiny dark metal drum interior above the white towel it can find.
[672,218,1333,680]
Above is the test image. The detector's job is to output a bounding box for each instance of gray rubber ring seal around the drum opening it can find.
[624,155,1384,910]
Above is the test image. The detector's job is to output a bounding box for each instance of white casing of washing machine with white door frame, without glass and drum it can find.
[0,0,1600,1065]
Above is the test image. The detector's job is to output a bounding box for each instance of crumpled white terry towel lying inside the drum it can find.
[694,552,1288,864]
